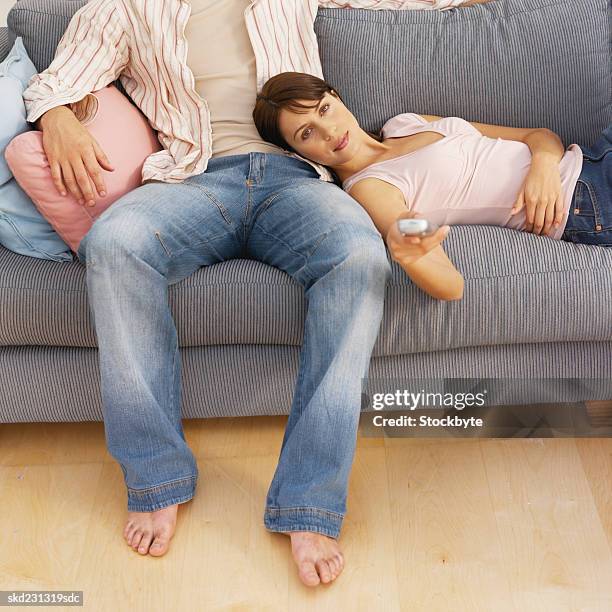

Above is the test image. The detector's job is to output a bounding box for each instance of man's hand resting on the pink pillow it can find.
[37,106,114,206]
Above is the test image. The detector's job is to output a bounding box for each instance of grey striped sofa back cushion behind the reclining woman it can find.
[315,0,612,145]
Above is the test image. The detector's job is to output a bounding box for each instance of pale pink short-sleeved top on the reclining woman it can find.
[342,113,582,239]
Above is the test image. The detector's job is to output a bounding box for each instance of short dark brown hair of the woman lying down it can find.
[253,72,382,151]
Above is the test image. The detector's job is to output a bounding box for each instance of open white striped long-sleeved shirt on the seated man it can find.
[23,0,466,183]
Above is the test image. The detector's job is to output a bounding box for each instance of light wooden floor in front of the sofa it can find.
[0,417,612,612]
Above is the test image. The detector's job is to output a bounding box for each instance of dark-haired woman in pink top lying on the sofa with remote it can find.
[253,72,612,299]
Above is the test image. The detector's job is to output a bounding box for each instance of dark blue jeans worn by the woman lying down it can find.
[561,125,612,247]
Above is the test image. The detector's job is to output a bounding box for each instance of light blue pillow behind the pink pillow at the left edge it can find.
[0,37,74,261]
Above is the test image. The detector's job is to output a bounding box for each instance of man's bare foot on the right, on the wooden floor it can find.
[287,531,344,586]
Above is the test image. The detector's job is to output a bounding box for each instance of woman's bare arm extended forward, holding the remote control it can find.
[350,178,464,300]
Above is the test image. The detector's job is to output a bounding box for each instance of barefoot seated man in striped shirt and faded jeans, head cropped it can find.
[24,0,486,586]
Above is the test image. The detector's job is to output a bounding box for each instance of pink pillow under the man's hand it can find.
[5,84,162,253]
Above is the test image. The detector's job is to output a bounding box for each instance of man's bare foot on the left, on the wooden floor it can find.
[123,504,178,557]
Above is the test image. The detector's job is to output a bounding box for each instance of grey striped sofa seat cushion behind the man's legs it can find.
[0,225,612,356]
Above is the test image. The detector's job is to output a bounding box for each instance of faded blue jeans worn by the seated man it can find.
[78,153,390,538]
